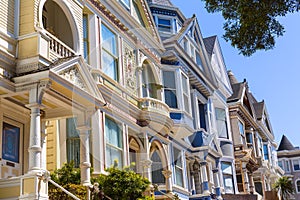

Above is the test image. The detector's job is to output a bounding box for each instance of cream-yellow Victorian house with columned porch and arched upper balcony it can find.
[0,0,173,199]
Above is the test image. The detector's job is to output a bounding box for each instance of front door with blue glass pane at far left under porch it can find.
[0,118,23,178]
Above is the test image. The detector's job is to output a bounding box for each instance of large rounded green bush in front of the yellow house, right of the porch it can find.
[96,162,151,200]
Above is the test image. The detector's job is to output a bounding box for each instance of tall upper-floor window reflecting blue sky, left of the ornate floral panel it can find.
[101,24,118,81]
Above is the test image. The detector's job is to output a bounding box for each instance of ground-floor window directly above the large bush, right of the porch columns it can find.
[105,117,123,167]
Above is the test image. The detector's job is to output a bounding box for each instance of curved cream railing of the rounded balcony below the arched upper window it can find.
[139,98,170,117]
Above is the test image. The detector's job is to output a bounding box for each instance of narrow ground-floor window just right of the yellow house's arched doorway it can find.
[173,148,183,187]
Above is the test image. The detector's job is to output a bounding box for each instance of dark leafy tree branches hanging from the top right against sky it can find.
[202,0,300,56]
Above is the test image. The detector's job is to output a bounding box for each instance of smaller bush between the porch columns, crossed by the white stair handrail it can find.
[48,162,86,199]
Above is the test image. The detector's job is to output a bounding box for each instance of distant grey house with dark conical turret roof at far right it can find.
[277,135,300,199]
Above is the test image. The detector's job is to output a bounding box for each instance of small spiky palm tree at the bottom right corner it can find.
[274,176,295,200]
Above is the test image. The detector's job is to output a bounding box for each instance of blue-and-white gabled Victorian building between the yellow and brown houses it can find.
[148,0,237,199]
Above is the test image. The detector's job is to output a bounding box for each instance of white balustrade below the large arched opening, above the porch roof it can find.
[46,32,75,60]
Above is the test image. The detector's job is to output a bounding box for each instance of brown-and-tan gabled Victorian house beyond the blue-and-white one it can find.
[227,71,283,199]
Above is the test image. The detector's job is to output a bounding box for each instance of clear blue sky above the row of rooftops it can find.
[172,0,300,146]
